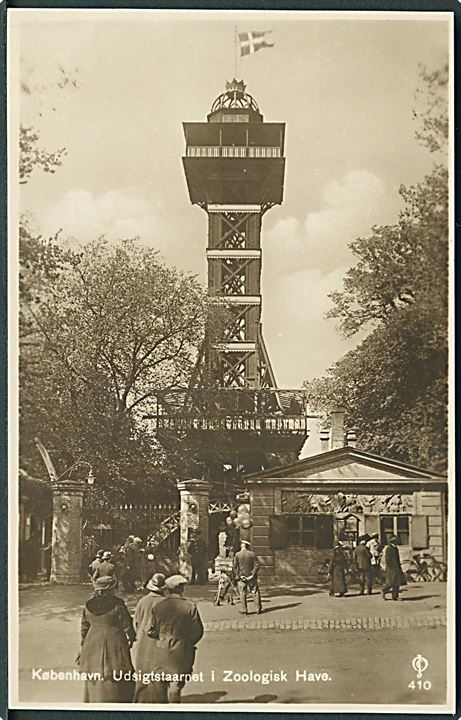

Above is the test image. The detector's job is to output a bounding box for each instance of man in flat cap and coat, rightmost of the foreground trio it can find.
[146,575,203,703]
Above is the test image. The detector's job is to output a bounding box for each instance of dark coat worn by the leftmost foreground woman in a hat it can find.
[80,594,135,680]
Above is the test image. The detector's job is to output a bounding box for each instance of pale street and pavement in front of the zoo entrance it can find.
[15,583,447,704]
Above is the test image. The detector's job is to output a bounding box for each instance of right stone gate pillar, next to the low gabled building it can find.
[177,480,210,580]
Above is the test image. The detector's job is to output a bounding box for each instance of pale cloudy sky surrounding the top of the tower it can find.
[8,9,450,388]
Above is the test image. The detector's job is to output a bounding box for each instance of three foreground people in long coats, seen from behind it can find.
[77,563,203,703]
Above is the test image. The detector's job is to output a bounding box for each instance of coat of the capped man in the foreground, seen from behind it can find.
[149,594,203,673]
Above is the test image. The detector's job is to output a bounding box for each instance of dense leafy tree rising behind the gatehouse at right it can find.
[306,68,448,471]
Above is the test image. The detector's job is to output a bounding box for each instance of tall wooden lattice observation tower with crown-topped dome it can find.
[155,79,307,496]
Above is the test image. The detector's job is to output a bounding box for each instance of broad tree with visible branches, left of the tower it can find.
[20,237,208,502]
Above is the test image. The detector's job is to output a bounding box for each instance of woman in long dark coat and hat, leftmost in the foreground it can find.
[79,576,135,703]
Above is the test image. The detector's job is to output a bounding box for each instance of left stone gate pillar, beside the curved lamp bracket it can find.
[50,480,85,585]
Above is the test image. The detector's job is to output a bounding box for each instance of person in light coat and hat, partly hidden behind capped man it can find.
[133,573,165,703]
